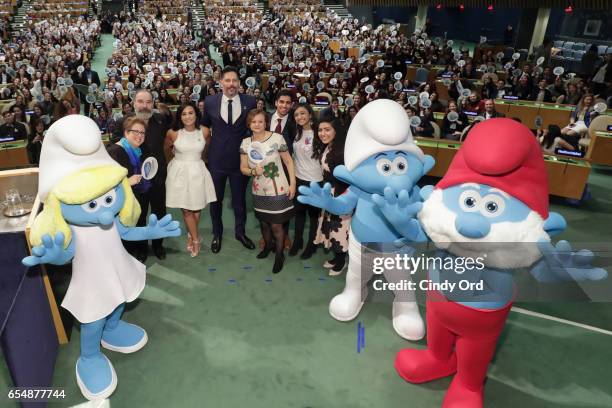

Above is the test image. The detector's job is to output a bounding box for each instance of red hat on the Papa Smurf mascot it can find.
[436,118,548,219]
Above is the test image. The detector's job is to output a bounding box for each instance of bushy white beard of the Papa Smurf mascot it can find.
[418,189,550,269]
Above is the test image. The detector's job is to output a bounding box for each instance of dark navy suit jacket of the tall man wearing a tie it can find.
[203,93,257,174]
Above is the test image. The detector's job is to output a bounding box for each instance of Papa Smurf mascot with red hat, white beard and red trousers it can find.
[375,119,607,408]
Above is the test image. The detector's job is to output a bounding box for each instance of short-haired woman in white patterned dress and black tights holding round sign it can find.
[240,109,296,273]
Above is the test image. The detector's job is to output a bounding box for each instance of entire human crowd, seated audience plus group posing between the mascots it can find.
[0,1,612,274]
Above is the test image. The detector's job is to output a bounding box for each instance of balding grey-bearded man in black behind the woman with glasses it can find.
[113,89,170,259]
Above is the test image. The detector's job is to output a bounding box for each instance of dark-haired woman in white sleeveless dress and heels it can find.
[165,103,217,257]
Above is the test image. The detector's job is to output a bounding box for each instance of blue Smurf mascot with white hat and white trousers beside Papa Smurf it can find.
[298,99,434,340]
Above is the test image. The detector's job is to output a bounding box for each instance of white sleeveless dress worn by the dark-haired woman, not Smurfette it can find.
[166,128,217,211]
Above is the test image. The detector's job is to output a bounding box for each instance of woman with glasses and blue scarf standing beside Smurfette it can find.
[107,116,151,263]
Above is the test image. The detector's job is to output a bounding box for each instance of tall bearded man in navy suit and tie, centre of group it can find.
[203,66,257,253]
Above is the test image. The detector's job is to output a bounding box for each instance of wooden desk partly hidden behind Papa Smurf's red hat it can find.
[415,137,591,200]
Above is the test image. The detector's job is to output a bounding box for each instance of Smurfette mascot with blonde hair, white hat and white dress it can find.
[23,115,181,400]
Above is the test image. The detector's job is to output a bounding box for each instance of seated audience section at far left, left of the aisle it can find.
[0,15,100,163]
